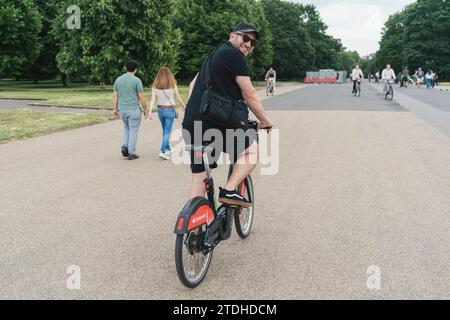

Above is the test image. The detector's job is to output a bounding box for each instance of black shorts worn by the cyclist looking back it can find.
[183,121,258,173]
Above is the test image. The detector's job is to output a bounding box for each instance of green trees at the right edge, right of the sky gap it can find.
[376,0,450,79]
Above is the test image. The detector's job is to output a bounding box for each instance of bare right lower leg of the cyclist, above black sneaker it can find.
[225,142,258,191]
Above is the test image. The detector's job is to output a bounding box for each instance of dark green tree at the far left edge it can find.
[0,0,42,78]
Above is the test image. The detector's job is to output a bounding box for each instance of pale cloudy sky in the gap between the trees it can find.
[290,0,416,56]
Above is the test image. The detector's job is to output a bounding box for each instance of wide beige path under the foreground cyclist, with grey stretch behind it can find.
[0,85,450,300]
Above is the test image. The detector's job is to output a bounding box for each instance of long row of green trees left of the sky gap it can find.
[0,0,370,84]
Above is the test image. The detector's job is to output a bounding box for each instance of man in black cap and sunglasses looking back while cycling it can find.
[182,23,273,207]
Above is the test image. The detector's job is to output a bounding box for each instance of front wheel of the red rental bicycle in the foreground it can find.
[234,176,255,239]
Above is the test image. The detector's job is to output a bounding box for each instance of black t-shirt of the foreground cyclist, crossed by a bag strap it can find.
[183,41,249,127]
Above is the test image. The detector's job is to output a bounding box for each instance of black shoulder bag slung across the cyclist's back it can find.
[200,48,248,129]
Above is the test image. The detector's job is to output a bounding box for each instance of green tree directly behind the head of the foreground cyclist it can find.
[174,0,272,80]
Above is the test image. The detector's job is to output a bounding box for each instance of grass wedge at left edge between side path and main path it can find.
[0,110,112,143]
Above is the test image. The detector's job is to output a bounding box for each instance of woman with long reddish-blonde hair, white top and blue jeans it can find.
[150,67,186,160]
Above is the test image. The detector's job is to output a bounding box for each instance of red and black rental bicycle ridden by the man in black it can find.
[175,121,258,288]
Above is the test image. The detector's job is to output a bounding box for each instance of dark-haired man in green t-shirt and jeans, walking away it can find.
[113,60,148,160]
